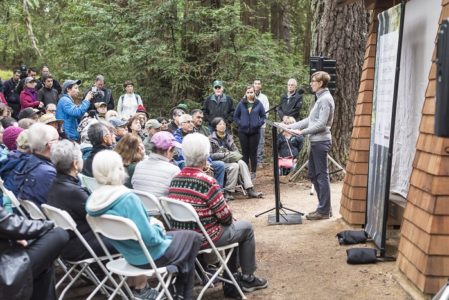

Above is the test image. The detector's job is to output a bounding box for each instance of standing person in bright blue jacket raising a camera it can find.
[56,79,93,142]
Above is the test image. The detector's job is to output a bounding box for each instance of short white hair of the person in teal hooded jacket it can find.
[92,150,127,185]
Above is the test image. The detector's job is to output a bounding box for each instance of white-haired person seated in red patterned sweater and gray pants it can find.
[168,133,268,296]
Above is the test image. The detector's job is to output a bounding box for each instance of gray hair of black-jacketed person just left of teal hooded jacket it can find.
[50,140,83,174]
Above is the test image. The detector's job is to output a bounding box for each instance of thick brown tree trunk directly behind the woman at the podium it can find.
[310,0,368,164]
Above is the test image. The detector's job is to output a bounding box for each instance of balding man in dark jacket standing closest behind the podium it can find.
[278,78,304,121]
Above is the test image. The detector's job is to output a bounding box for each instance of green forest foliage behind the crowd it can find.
[0,0,308,114]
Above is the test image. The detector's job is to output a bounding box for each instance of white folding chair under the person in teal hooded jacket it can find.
[86,215,176,300]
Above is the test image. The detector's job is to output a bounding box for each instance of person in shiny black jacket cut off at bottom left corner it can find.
[0,207,69,300]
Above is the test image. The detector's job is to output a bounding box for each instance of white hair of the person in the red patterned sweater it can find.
[182,133,210,167]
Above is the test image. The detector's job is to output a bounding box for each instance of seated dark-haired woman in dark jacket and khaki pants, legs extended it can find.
[209,117,262,200]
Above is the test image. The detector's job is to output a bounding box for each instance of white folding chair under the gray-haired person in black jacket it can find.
[41,204,127,299]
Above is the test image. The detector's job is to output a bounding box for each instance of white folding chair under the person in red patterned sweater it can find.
[160,197,246,299]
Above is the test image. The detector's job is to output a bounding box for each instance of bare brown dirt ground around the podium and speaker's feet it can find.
[67,167,412,300]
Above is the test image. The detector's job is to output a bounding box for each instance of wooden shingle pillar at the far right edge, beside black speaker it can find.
[397,0,449,294]
